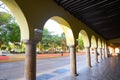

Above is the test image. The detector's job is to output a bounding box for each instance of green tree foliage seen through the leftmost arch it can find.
[0,12,20,47]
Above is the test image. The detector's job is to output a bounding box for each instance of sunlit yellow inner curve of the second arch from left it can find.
[43,16,75,46]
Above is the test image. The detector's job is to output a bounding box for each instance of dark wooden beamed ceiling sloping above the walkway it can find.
[54,0,120,40]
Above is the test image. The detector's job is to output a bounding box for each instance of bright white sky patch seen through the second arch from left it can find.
[44,19,63,35]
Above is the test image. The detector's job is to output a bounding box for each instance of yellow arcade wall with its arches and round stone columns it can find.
[2,0,110,80]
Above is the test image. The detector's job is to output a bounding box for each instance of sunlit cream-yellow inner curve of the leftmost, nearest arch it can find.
[2,0,30,40]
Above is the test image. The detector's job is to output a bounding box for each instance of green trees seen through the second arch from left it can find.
[37,28,66,53]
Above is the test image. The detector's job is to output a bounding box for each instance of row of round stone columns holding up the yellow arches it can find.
[24,40,108,80]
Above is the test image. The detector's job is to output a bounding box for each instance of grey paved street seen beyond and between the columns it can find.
[0,55,94,80]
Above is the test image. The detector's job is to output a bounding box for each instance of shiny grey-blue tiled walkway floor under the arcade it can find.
[37,57,120,80]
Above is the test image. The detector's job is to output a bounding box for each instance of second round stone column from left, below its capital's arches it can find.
[69,45,77,76]
